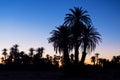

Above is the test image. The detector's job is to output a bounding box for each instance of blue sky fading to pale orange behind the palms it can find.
[0,0,120,61]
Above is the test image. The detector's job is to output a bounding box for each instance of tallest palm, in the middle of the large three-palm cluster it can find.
[64,7,91,63]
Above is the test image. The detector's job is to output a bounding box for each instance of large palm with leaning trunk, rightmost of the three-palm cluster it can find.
[80,26,101,64]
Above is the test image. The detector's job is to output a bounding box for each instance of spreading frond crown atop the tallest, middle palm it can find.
[64,7,91,26]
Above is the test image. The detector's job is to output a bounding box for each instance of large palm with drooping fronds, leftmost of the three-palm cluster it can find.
[48,25,72,64]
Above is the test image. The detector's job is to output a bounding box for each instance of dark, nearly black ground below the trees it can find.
[0,66,120,80]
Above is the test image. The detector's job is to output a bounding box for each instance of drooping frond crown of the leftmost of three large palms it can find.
[49,25,70,53]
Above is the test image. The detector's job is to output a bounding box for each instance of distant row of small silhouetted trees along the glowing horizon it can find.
[1,44,120,67]
